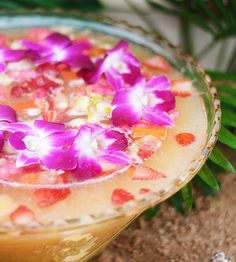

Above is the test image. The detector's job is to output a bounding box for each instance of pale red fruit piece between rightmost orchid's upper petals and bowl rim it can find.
[171,79,193,97]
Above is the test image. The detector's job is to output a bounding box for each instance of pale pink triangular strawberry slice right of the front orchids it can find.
[131,165,166,180]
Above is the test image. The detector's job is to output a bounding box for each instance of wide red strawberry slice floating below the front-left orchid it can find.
[33,188,71,208]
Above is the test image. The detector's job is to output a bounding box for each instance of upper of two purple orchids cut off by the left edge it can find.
[0,48,25,73]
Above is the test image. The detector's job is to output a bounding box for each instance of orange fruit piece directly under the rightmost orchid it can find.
[132,126,167,141]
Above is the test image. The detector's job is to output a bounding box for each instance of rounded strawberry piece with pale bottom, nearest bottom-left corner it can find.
[10,205,35,225]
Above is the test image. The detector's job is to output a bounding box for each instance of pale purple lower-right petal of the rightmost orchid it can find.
[143,108,173,127]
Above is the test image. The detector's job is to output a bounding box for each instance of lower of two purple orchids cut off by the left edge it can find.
[0,105,17,151]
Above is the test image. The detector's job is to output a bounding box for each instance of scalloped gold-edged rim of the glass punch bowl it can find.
[0,9,221,235]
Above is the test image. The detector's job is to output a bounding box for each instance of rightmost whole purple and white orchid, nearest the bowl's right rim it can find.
[112,76,175,126]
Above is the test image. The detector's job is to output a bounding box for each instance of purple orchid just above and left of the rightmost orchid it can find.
[79,40,141,89]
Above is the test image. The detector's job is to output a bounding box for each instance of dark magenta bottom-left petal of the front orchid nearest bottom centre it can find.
[73,157,102,181]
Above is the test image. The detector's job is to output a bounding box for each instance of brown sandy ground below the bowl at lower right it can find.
[93,155,236,262]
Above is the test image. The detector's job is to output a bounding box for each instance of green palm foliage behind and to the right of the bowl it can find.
[0,0,236,217]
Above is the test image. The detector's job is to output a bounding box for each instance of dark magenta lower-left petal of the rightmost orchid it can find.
[112,104,142,126]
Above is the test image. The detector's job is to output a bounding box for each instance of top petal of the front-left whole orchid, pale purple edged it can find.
[34,120,65,136]
